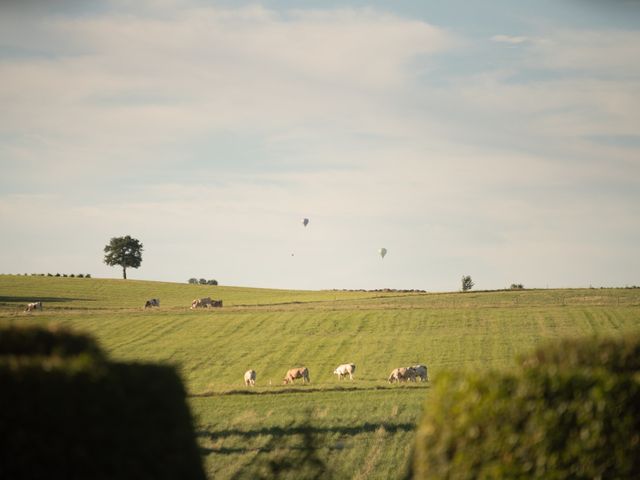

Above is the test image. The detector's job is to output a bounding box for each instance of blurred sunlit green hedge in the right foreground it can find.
[413,337,640,479]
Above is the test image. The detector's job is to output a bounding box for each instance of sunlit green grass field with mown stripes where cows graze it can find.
[0,275,640,479]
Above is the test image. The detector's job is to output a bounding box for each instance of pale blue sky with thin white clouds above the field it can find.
[0,0,640,291]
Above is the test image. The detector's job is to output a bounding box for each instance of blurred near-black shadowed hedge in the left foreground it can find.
[0,329,205,479]
